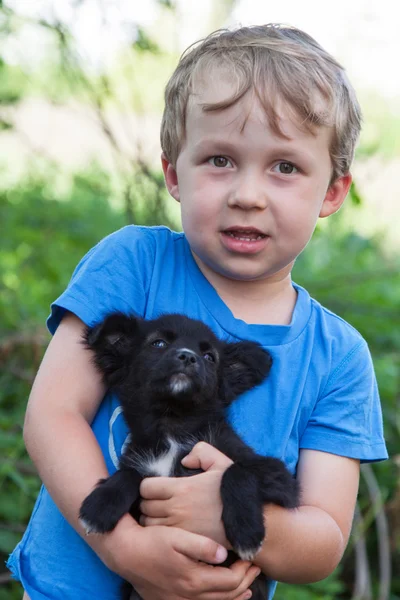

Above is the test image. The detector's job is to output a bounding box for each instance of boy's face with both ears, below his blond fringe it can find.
[163,78,351,289]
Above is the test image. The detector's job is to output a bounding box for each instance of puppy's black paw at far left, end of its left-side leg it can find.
[79,482,124,534]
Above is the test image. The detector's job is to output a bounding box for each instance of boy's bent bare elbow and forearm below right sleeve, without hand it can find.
[254,450,360,583]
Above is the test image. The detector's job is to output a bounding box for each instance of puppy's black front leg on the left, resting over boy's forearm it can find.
[79,469,143,533]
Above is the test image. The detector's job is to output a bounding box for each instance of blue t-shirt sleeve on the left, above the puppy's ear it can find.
[47,226,155,334]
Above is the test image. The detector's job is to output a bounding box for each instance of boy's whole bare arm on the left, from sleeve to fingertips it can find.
[24,314,256,600]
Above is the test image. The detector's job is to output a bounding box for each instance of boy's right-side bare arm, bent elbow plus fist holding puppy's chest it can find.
[141,443,359,583]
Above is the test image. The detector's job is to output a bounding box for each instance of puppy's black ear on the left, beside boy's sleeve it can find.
[83,313,141,387]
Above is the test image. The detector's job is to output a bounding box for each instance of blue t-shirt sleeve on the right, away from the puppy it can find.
[300,340,388,462]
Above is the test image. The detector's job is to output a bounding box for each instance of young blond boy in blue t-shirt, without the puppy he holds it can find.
[9,25,386,600]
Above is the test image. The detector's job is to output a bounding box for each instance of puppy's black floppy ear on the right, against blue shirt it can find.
[220,342,272,406]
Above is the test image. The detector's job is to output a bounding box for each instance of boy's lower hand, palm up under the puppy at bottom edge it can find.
[107,526,259,600]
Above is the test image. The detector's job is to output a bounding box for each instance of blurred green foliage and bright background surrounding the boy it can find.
[0,0,400,600]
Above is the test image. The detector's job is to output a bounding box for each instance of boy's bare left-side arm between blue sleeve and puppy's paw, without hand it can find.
[24,314,108,529]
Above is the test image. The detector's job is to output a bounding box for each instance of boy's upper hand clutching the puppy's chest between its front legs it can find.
[140,442,232,548]
